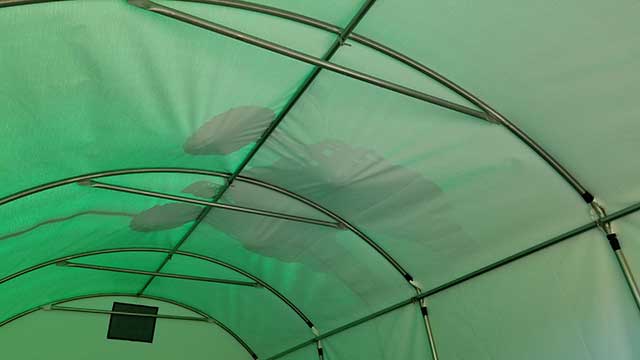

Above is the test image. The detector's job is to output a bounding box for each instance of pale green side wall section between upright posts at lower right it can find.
[429,230,640,360]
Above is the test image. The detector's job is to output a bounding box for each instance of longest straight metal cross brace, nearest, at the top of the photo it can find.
[129,0,493,122]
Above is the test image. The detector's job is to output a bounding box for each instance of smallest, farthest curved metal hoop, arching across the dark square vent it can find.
[0,293,258,359]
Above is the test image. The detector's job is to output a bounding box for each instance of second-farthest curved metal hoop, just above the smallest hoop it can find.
[0,247,311,327]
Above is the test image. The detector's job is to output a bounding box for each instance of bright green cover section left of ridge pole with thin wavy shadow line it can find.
[0,184,188,275]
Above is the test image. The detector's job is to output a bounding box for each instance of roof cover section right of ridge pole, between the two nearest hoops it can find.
[242,72,589,288]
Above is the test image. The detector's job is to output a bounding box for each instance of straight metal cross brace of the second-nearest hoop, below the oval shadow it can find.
[78,180,342,229]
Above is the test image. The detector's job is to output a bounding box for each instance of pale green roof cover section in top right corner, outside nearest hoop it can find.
[357,0,640,208]
